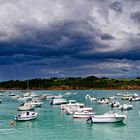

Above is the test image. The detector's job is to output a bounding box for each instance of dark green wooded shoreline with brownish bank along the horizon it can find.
[0,76,140,90]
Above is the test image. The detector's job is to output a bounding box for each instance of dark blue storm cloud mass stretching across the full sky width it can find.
[0,19,140,65]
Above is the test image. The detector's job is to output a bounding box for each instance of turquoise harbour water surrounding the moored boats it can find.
[0,90,140,140]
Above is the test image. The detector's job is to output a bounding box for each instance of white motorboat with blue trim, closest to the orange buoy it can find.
[14,111,38,121]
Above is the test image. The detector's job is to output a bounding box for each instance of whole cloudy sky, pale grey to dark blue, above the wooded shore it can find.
[0,0,140,81]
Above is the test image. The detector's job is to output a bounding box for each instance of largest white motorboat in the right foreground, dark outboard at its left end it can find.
[87,111,126,123]
